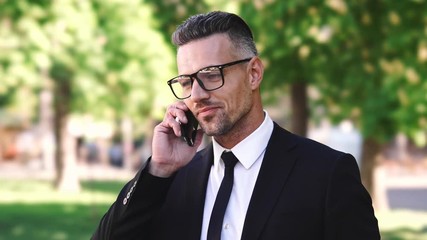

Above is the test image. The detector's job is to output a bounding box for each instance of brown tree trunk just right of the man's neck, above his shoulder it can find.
[291,82,309,136]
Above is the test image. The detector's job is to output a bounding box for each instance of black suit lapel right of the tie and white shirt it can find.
[242,124,296,240]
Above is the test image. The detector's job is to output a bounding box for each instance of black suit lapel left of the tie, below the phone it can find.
[186,144,213,239]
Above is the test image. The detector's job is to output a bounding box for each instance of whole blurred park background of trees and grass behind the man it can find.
[0,0,427,240]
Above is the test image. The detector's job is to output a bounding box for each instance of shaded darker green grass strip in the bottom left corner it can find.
[0,204,107,240]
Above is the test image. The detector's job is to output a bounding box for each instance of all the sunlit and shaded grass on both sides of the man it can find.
[0,179,427,240]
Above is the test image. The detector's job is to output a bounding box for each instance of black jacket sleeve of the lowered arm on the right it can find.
[325,154,380,240]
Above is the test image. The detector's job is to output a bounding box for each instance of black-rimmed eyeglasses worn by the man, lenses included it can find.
[168,58,252,100]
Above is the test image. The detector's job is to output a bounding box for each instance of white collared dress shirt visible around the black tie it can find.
[200,111,273,240]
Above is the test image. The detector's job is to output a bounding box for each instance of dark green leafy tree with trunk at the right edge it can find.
[331,1,427,190]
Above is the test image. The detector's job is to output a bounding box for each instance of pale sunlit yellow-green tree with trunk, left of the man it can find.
[0,0,173,191]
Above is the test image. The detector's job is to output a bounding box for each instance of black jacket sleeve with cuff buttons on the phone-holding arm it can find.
[91,161,173,240]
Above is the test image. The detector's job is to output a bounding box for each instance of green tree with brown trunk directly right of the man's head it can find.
[241,0,360,136]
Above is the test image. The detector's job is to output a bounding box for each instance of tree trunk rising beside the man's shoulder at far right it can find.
[361,138,381,196]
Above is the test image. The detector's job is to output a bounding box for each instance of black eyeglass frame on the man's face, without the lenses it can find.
[167,57,253,100]
